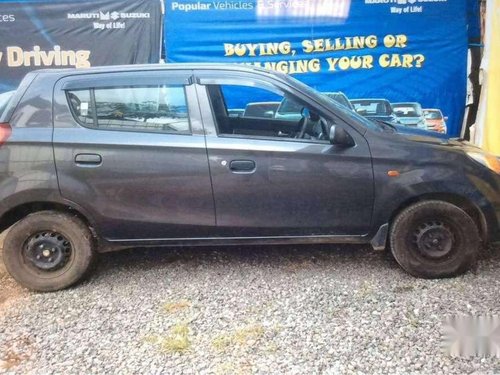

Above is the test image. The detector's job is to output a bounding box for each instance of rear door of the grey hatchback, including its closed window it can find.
[53,70,215,240]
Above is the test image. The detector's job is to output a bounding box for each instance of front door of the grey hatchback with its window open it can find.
[196,72,374,237]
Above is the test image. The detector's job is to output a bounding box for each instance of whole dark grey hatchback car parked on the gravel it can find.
[0,64,500,291]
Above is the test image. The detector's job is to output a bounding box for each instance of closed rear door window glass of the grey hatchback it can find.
[67,85,190,134]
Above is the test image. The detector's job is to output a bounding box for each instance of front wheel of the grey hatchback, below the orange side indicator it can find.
[390,200,481,279]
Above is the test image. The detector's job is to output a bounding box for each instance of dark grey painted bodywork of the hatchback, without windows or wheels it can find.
[0,64,500,251]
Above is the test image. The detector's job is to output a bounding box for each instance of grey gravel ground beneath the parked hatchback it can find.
[0,242,500,374]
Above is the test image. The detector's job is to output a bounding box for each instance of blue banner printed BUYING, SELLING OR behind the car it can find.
[164,0,467,136]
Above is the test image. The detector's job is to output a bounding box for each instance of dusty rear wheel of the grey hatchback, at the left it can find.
[3,211,94,292]
